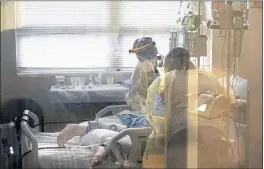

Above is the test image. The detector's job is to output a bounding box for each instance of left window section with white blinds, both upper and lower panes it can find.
[16,1,113,72]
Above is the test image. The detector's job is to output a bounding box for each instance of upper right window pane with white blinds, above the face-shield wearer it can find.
[120,1,180,28]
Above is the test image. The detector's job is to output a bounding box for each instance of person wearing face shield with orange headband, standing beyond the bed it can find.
[126,37,162,112]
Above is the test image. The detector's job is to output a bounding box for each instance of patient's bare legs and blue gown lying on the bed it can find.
[57,111,147,167]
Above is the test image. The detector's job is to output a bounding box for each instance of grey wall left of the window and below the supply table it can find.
[1,1,129,131]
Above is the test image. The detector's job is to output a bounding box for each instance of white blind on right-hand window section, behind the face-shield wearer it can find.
[117,1,180,66]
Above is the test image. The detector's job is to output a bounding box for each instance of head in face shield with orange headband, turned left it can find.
[129,37,158,72]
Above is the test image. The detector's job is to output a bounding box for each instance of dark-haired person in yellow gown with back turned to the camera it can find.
[143,47,223,168]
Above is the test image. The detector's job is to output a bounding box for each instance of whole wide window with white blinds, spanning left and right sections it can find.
[16,1,191,73]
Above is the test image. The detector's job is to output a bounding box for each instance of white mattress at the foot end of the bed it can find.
[32,133,96,168]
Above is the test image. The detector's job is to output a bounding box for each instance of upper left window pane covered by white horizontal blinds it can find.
[17,1,110,27]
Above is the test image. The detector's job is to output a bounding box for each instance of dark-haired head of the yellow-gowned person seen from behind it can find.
[163,47,195,72]
